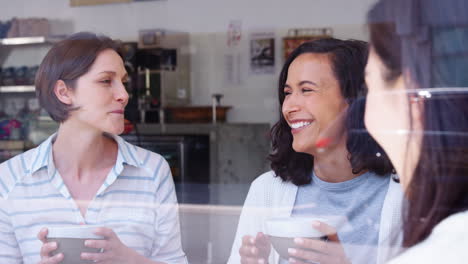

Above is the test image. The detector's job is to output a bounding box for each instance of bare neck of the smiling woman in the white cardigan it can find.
[313,137,362,183]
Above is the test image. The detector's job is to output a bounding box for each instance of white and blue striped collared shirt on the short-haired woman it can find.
[0,135,187,264]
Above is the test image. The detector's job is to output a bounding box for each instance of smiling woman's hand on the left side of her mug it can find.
[239,232,271,264]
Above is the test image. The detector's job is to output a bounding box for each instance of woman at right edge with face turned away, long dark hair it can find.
[365,0,468,264]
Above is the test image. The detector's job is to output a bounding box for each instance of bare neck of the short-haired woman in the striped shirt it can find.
[52,121,117,180]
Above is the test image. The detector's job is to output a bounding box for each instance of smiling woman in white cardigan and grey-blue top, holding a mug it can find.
[228,38,402,263]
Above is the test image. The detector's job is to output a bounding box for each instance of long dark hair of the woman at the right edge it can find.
[368,0,468,247]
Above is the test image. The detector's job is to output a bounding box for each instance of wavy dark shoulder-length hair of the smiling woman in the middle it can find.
[268,38,393,186]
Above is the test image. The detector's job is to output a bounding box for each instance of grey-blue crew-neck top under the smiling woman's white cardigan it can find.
[280,172,390,264]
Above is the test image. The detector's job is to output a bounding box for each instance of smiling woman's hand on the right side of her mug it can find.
[288,221,351,264]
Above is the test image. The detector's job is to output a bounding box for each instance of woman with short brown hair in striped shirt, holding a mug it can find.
[0,33,187,264]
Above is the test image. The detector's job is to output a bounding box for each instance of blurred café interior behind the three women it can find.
[0,0,374,264]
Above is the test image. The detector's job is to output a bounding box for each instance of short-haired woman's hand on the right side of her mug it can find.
[81,227,141,264]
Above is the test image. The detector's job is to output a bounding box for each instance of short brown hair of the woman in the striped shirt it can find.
[35,32,119,123]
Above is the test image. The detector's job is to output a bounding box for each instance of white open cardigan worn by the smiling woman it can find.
[227,171,403,264]
